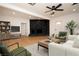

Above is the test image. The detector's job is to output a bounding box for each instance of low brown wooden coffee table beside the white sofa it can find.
[38,39,60,50]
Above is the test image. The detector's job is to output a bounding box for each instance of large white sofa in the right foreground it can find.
[48,36,79,56]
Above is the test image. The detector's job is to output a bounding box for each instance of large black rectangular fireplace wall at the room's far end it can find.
[30,19,49,36]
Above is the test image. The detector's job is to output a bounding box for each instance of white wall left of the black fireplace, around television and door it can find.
[0,15,29,36]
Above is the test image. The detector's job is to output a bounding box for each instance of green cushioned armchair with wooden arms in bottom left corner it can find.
[0,43,31,56]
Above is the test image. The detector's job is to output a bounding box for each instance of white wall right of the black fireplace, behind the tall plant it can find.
[50,13,79,35]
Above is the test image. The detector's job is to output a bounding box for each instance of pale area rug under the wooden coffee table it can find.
[25,44,48,56]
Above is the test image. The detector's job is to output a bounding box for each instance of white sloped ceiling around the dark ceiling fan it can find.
[0,3,79,19]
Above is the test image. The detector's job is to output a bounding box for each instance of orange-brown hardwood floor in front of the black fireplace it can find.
[3,36,48,47]
